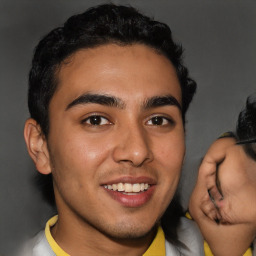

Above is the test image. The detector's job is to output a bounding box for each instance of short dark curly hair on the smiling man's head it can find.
[28,4,196,136]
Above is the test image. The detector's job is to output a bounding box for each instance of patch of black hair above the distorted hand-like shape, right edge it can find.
[236,94,256,161]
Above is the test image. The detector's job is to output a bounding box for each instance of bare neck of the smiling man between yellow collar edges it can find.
[51,212,156,256]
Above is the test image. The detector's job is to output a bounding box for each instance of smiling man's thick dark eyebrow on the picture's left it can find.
[66,93,125,110]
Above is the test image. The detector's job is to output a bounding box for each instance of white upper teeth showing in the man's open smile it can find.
[104,183,150,193]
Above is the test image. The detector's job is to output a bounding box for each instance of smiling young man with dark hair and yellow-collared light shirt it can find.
[24,5,203,256]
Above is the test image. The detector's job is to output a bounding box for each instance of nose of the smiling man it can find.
[113,123,153,167]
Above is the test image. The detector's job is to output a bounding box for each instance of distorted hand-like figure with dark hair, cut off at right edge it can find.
[189,96,256,256]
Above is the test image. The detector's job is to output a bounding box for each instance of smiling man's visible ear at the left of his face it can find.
[24,118,51,174]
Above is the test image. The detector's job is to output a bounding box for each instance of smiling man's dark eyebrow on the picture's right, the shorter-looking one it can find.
[143,95,182,110]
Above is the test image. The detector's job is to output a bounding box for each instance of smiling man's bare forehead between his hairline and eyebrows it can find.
[52,44,182,107]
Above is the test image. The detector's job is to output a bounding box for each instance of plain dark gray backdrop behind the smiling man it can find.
[0,0,256,254]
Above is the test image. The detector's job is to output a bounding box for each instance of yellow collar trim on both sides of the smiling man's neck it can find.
[45,215,165,256]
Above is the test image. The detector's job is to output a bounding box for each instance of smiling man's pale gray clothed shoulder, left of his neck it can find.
[17,231,55,256]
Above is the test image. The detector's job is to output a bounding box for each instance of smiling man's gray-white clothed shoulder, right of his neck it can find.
[165,217,204,256]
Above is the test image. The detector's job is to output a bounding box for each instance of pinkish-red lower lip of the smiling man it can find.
[103,186,155,208]
